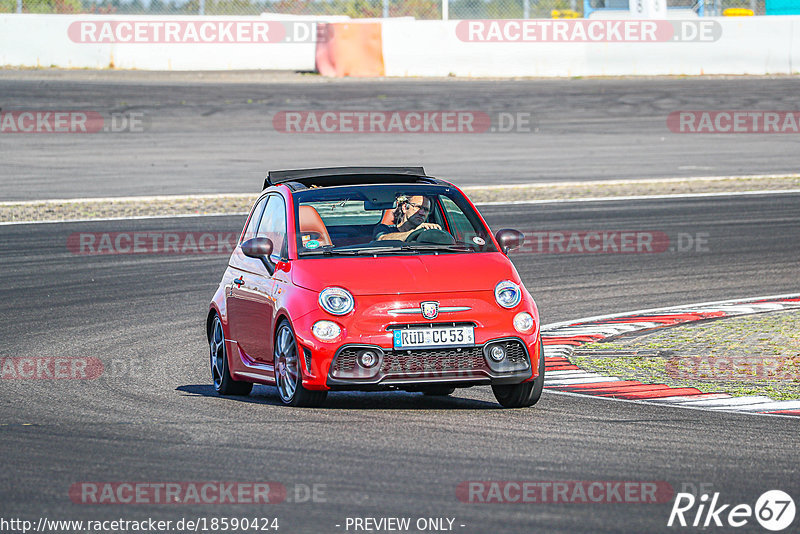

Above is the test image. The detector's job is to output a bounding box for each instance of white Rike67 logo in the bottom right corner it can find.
[667,490,795,532]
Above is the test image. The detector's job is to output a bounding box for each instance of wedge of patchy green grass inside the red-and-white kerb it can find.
[571,310,800,400]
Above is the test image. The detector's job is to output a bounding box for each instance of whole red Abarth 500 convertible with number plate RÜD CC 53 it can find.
[207,167,544,408]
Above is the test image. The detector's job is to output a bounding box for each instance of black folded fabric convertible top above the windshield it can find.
[264,167,446,193]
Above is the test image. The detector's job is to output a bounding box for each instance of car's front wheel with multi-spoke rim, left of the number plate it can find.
[274,320,328,408]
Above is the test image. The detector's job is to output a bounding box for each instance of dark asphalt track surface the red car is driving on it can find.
[0,195,800,533]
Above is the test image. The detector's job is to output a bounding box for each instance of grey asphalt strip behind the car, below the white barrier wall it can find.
[0,70,800,200]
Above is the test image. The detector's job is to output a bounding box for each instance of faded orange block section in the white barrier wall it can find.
[316,22,386,77]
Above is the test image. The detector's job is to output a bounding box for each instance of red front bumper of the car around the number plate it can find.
[292,291,539,390]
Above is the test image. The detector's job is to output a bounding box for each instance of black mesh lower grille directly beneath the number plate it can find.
[381,347,487,375]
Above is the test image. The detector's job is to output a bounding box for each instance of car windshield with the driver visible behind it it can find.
[294,184,497,257]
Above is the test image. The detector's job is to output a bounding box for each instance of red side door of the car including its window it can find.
[228,194,286,366]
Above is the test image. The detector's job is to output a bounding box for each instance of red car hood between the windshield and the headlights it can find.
[291,252,520,295]
